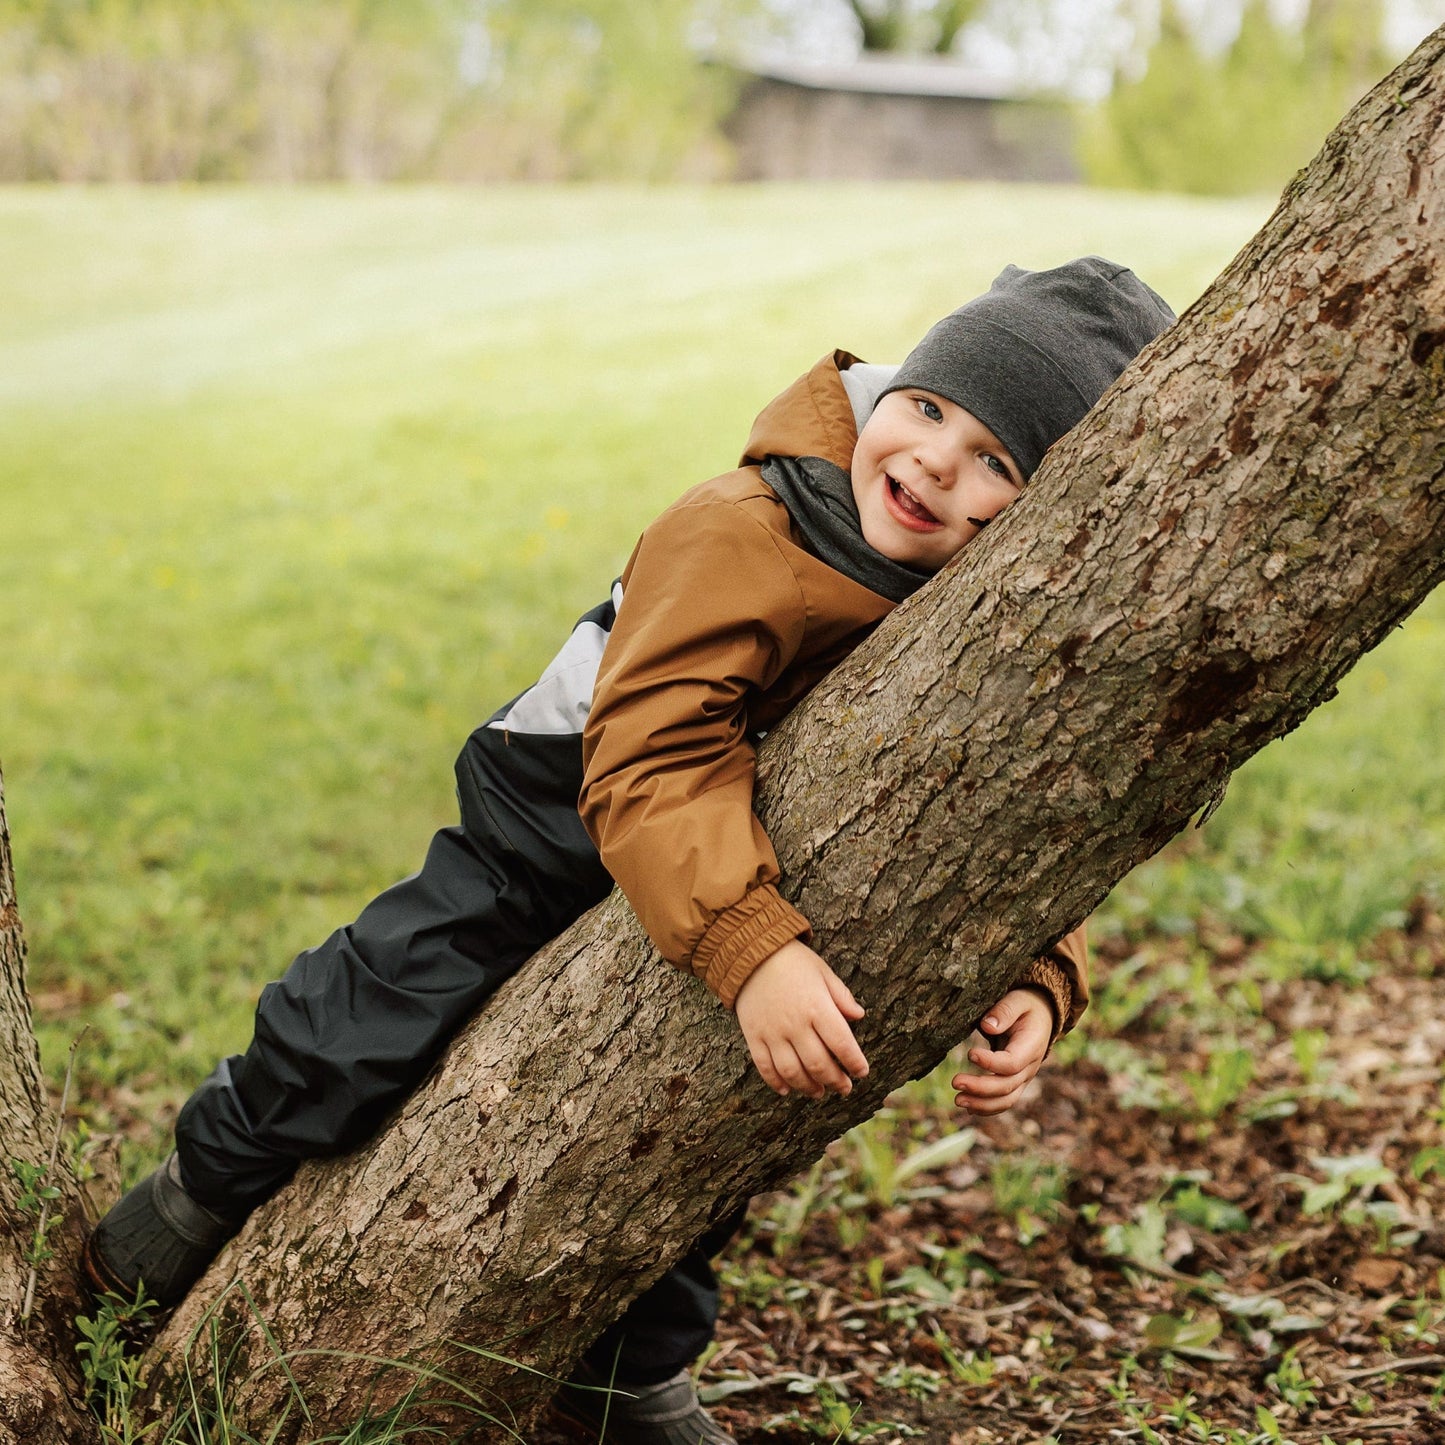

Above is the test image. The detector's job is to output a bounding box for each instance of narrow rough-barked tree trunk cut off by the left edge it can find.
[0,780,98,1445]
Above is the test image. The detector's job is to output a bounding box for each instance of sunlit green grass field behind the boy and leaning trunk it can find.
[0,186,1445,1153]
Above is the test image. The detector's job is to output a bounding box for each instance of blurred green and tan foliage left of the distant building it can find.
[0,0,727,181]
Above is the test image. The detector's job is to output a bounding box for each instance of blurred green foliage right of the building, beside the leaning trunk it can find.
[1081,0,1393,195]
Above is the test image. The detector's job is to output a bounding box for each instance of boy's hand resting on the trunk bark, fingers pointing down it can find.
[733,938,867,1098]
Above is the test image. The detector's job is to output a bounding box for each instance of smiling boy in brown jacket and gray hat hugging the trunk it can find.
[87,257,1172,1445]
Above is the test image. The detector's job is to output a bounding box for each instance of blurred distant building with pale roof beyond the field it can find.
[724,55,1079,181]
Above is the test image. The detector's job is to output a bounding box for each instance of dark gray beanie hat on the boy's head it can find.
[884,256,1175,477]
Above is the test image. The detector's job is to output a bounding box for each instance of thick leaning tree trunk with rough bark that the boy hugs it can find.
[127,30,1445,1429]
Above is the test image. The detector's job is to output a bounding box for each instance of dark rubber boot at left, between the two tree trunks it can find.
[84,1155,244,1309]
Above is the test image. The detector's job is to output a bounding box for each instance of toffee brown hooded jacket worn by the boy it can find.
[579,351,1088,1033]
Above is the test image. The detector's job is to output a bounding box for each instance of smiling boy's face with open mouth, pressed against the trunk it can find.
[853,387,1023,572]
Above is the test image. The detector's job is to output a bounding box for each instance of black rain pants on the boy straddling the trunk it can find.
[176,709,743,1384]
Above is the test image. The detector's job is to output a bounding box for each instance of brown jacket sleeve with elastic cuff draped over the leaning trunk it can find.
[578,501,811,1007]
